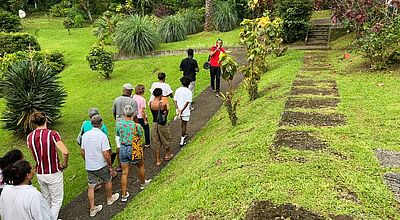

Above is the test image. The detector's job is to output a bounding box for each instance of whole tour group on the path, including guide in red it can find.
[0,39,225,220]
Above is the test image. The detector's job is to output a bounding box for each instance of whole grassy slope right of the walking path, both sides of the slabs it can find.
[115,36,400,219]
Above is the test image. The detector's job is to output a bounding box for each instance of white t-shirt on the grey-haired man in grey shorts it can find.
[81,128,111,171]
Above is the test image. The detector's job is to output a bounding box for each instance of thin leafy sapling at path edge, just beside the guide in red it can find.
[219,53,239,126]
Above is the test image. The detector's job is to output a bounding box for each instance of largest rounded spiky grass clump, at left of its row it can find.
[114,15,160,55]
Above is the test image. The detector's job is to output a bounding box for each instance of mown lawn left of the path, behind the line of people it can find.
[0,18,236,203]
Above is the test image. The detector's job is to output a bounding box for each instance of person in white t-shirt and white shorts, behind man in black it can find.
[174,76,193,147]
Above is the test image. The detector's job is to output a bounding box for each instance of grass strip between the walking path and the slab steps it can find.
[116,51,303,219]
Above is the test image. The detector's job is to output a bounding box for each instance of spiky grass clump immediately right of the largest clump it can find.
[158,15,186,43]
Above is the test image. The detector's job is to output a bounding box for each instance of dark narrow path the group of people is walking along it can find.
[59,48,245,220]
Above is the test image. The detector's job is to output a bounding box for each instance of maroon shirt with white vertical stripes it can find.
[26,129,62,174]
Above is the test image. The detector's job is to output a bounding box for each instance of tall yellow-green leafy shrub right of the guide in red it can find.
[240,16,286,100]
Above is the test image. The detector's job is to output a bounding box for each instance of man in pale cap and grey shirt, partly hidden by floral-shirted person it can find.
[112,83,138,171]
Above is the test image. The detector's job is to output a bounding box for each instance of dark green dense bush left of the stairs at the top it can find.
[274,0,314,43]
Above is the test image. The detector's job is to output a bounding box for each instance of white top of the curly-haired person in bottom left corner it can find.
[0,185,51,220]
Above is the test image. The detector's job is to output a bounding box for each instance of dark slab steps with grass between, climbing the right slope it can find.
[246,51,358,220]
